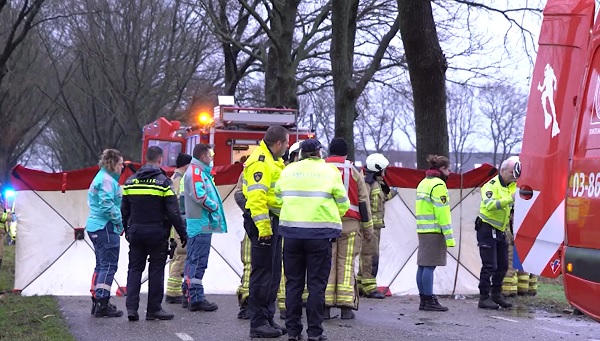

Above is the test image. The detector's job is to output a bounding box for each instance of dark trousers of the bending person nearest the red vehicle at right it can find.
[477,222,508,296]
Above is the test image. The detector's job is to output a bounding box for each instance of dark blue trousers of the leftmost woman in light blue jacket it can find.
[88,222,121,298]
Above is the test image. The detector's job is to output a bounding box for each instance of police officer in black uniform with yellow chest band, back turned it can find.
[121,146,187,321]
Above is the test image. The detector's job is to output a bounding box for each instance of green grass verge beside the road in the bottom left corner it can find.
[0,245,75,341]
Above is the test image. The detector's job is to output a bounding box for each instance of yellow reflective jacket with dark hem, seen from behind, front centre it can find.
[275,158,350,239]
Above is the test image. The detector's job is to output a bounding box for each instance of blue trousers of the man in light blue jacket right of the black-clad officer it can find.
[182,233,212,303]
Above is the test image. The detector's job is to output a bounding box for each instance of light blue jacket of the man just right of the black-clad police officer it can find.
[183,159,227,238]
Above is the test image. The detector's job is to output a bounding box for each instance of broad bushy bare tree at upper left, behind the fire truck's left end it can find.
[48,0,213,168]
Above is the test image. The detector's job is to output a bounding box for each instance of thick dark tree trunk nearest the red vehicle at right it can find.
[399,0,449,169]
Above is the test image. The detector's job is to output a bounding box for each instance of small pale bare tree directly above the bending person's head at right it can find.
[478,83,527,165]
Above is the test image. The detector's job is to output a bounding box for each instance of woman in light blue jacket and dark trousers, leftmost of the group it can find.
[85,149,123,317]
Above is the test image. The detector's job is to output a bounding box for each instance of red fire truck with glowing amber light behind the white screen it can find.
[142,96,314,169]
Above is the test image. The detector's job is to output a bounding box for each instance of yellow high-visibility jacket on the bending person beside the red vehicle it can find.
[479,175,517,232]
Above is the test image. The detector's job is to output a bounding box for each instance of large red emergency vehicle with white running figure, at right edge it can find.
[514,0,600,321]
